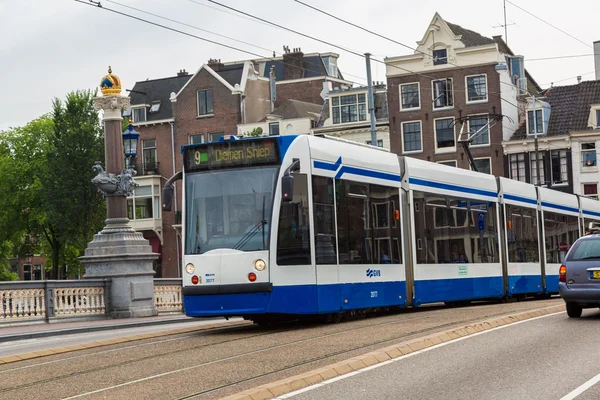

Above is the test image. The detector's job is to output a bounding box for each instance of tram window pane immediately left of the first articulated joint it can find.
[369,185,401,264]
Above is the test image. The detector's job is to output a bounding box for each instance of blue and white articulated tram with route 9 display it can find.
[163,135,584,321]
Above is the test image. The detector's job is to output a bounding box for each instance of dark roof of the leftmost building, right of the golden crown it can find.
[129,75,192,121]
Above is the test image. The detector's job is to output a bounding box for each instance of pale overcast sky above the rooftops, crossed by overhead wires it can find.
[0,0,600,131]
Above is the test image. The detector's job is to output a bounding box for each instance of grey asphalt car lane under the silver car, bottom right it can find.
[282,310,600,400]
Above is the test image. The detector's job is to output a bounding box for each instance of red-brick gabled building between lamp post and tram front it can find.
[127,49,351,277]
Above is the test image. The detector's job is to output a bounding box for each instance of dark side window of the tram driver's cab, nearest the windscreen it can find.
[277,174,311,265]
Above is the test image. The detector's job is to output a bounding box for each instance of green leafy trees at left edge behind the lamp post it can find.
[0,91,106,279]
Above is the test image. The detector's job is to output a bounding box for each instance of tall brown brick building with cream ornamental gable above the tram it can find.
[386,13,540,176]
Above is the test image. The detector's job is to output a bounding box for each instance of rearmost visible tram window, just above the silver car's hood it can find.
[544,211,579,264]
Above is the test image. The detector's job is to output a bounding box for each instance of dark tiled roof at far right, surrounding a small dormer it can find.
[511,81,600,140]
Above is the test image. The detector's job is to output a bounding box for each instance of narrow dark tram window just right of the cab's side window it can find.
[312,176,341,265]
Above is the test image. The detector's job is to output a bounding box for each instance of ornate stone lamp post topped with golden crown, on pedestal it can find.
[80,67,158,318]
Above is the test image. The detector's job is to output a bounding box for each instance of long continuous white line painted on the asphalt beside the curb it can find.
[273,311,564,400]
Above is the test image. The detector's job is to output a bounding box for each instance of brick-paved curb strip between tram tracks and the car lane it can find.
[221,305,565,400]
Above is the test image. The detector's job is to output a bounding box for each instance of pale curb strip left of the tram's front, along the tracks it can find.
[0,322,246,365]
